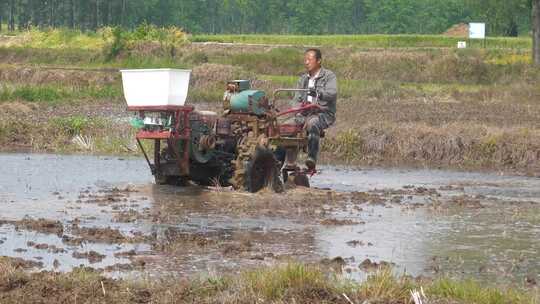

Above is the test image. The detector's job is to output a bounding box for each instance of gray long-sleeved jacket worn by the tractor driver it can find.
[293,68,337,118]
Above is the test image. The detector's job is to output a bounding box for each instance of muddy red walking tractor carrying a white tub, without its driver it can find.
[121,69,320,192]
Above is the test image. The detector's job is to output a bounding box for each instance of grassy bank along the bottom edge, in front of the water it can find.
[0,259,539,304]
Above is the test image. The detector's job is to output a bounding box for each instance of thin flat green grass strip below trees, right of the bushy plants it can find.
[190,35,532,49]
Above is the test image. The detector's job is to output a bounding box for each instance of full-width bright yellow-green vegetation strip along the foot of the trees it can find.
[0,24,532,49]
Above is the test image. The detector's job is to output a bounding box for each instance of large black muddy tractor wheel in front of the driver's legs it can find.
[244,147,283,193]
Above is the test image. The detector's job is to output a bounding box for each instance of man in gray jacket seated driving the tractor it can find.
[293,49,337,170]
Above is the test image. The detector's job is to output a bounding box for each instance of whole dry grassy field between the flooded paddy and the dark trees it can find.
[0,27,540,174]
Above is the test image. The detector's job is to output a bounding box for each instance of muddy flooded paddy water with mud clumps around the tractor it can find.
[0,154,540,285]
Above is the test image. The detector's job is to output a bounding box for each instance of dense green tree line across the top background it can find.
[0,0,536,36]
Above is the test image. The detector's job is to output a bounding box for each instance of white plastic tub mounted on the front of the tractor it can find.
[120,69,191,107]
